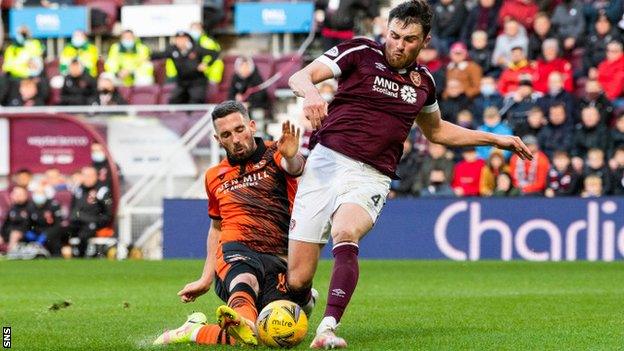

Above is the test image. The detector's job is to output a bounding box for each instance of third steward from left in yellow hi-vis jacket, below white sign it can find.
[104,30,154,87]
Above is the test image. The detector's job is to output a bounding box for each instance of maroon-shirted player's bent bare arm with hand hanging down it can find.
[288,60,334,129]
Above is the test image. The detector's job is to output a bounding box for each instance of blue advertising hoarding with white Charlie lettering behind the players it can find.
[163,197,624,261]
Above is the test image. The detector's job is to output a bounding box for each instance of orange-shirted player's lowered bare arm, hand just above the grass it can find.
[178,219,221,302]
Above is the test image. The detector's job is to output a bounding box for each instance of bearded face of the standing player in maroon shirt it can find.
[385,18,431,68]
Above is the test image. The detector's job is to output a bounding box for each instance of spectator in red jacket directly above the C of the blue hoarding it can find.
[451,146,485,196]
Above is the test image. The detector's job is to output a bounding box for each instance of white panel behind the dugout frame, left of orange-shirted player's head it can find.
[107,117,197,177]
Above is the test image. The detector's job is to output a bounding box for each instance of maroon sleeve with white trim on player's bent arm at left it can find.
[315,38,377,78]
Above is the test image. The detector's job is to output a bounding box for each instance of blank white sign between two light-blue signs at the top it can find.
[121,5,202,37]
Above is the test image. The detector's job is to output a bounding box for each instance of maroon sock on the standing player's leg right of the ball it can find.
[325,243,360,322]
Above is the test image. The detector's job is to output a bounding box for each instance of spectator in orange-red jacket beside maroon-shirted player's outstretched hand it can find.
[509,135,550,195]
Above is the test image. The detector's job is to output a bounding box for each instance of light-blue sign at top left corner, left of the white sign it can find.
[9,6,90,39]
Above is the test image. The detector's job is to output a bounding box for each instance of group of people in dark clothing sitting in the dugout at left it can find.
[0,143,114,258]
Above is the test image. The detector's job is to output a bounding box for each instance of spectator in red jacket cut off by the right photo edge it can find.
[590,41,624,101]
